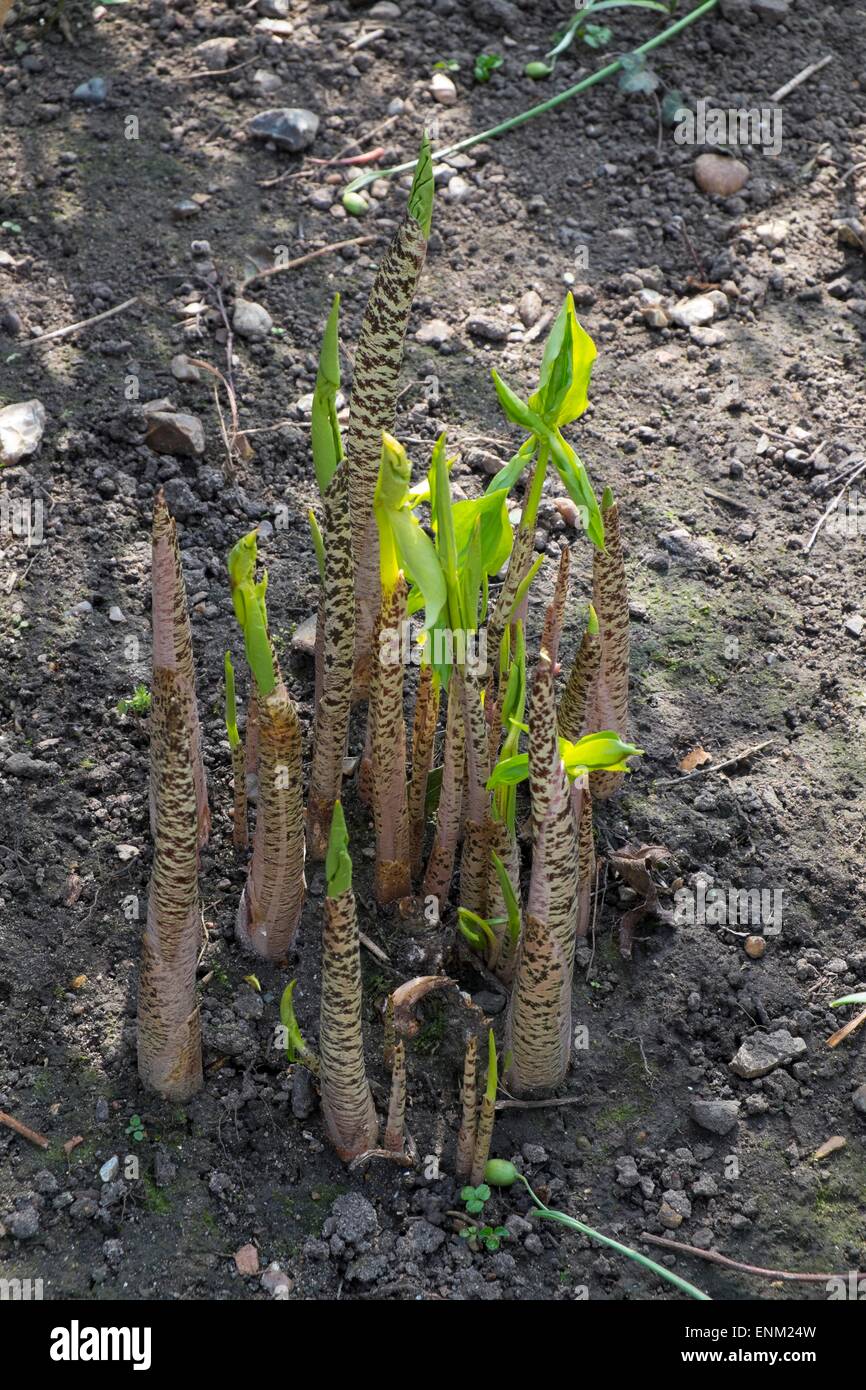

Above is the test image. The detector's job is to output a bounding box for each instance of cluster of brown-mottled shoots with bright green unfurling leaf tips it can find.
[139,135,664,1306]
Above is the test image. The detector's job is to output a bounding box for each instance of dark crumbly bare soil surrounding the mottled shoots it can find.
[0,0,866,1301]
